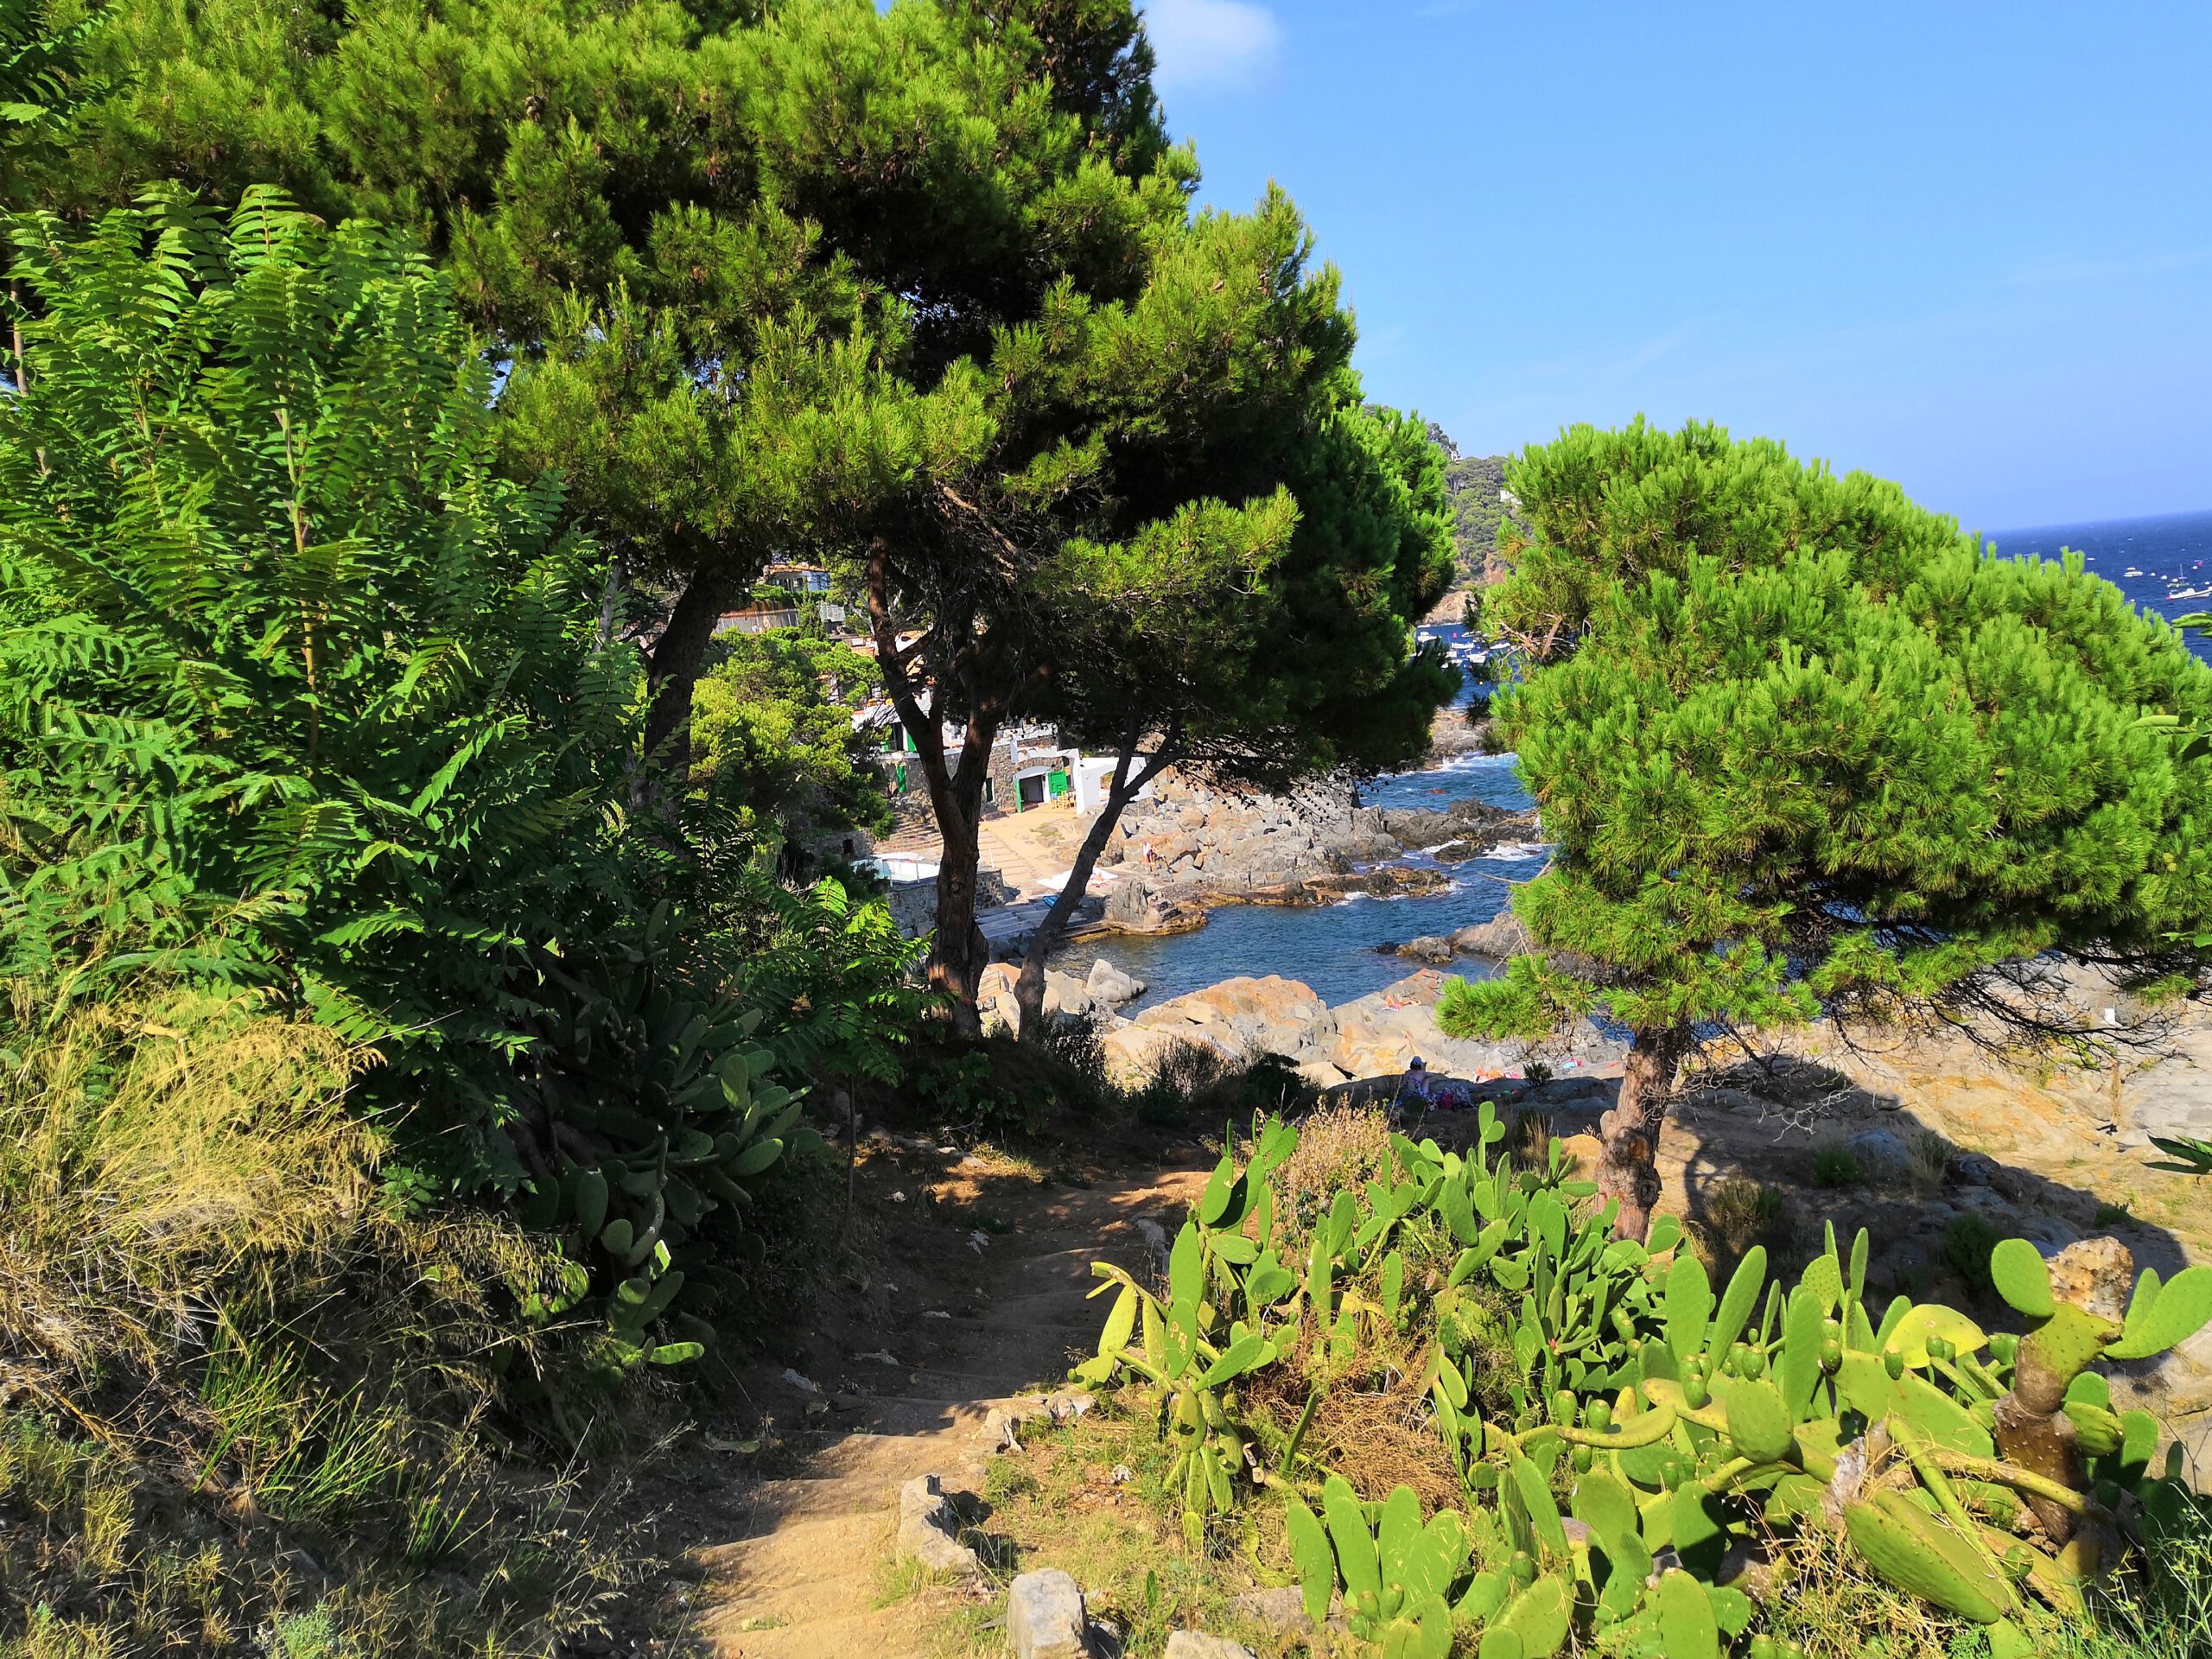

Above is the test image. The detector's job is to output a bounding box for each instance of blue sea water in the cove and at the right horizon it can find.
[1053,511,2212,1013]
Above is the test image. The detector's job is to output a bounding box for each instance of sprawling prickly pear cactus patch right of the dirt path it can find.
[1077,1110,2212,1659]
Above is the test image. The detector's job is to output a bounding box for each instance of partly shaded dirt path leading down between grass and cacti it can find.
[696,1173,1205,1659]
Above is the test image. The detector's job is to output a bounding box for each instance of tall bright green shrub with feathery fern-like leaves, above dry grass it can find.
[0,190,641,1185]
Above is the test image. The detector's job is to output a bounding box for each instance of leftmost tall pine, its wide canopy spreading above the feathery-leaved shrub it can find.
[35,0,1194,736]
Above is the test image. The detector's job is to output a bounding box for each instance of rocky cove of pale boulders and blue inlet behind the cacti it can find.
[984,734,2212,1484]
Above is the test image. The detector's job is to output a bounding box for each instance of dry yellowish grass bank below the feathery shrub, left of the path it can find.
[0,995,658,1659]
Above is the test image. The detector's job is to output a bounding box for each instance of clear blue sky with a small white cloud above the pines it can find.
[1146,0,2212,531]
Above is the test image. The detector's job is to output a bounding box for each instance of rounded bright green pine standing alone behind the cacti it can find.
[1440,423,2212,1234]
